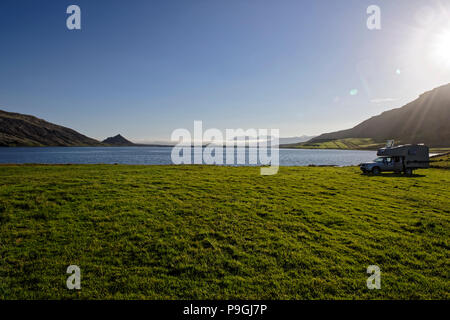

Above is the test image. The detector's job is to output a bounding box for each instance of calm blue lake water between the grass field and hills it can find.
[0,147,376,166]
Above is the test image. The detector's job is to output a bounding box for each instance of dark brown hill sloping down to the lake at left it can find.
[0,110,101,147]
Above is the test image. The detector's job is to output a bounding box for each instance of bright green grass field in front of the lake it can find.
[0,165,450,299]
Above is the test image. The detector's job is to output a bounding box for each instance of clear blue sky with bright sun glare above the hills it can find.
[0,0,450,141]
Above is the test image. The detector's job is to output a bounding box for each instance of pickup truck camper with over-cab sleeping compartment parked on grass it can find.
[360,143,430,175]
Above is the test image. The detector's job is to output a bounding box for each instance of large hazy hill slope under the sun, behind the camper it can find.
[296,84,450,147]
